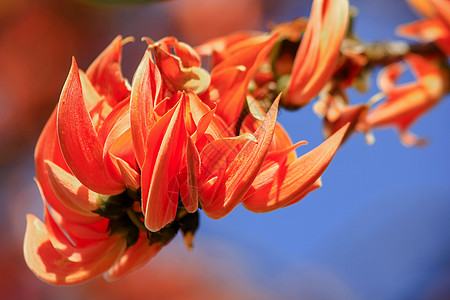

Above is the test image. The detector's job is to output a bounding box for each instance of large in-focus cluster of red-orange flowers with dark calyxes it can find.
[24,26,348,284]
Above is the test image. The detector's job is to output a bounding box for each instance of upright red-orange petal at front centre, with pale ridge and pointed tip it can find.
[141,94,187,232]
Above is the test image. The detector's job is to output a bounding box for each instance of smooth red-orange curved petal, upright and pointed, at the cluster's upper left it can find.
[57,59,124,195]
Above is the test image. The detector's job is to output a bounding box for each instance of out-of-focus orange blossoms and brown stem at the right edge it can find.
[308,0,450,146]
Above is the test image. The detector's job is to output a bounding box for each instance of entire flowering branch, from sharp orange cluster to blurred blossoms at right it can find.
[24,0,449,285]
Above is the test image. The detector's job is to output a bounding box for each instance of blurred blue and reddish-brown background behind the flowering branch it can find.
[0,0,450,300]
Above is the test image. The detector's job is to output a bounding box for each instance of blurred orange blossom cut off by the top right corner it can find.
[397,0,450,55]
